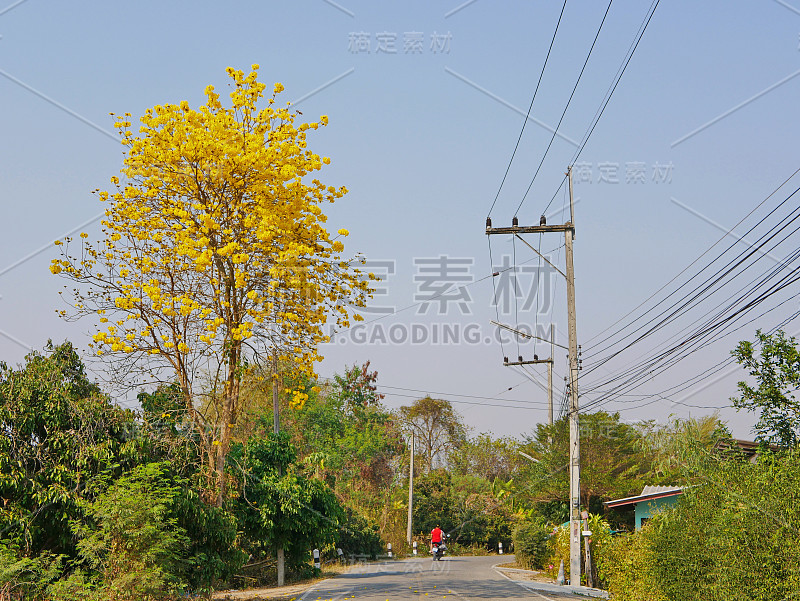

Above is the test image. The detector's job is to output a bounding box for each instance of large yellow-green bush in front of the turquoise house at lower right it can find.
[599,450,800,601]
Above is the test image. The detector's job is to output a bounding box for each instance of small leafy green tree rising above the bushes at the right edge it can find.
[731,330,800,447]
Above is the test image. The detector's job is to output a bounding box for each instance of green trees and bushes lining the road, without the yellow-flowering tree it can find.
[0,328,800,601]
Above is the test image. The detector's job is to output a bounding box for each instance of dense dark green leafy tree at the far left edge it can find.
[0,342,136,557]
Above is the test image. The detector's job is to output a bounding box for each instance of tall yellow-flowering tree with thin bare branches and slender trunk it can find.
[50,65,374,503]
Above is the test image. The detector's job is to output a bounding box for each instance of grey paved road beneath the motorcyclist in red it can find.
[297,556,585,601]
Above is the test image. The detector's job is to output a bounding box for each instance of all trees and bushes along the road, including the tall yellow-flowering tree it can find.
[0,65,800,601]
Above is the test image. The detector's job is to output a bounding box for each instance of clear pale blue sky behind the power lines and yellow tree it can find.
[0,0,800,438]
